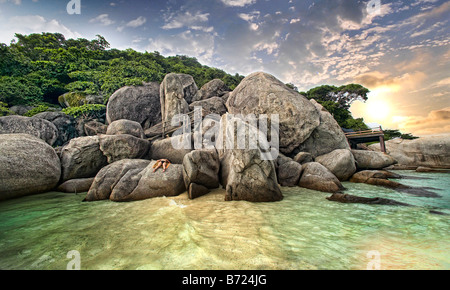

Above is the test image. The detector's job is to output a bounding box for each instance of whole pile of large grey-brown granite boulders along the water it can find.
[0,72,449,202]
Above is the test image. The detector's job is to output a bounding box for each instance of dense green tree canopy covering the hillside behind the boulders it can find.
[0,33,244,106]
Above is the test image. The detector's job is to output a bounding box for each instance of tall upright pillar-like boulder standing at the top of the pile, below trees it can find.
[160,73,198,122]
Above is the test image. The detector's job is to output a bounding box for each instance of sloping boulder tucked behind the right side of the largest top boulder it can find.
[294,100,350,158]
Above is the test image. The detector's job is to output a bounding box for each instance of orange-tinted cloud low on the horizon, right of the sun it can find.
[398,107,450,135]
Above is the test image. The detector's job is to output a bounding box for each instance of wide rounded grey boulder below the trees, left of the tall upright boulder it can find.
[106,83,161,129]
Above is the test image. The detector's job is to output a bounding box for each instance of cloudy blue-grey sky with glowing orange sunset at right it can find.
[0,0,450,136]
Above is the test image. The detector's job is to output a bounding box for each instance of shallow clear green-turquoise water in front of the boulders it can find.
[0,171,450,269]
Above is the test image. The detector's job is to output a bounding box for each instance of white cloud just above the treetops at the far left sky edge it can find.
[0,15,82,43]
